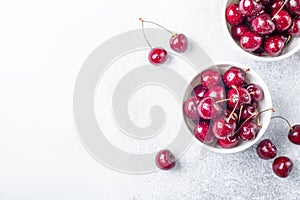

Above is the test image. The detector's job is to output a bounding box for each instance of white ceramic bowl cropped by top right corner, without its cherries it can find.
[222,0,300,61]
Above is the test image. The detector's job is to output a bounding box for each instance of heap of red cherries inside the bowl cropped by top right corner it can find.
[225,0,300,57]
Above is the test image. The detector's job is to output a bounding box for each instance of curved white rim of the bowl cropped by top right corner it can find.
[222,0,300,61]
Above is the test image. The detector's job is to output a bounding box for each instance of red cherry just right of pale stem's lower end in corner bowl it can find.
[272,10,292,32]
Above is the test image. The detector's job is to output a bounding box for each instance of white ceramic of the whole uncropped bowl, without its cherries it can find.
[184,62,272,153]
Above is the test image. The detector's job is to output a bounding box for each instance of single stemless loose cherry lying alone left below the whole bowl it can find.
[155,149,176,170]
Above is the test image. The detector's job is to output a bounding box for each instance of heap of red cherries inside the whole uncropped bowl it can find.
[183,66,270,148]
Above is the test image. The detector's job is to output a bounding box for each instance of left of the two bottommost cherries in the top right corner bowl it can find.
[240,31,263,52]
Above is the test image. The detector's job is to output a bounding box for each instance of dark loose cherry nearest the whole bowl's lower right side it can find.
[256,139,277,160]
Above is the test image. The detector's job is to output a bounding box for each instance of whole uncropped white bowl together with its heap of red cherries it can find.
[183,65,272,153]
